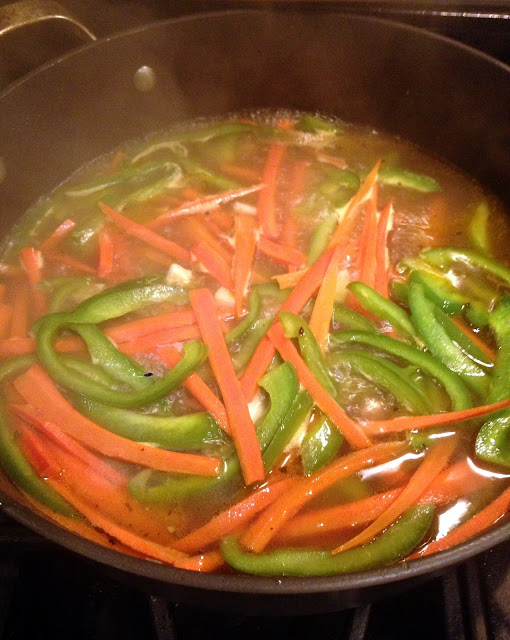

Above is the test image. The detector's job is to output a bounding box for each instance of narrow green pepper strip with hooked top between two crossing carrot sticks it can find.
[280,311,338,397]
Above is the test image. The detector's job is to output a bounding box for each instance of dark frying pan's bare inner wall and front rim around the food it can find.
[0,3,510,615]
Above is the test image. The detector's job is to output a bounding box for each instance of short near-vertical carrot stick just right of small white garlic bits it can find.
[232,214,257,317]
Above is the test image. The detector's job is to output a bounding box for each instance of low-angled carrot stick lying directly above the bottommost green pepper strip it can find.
[277,488,402,544]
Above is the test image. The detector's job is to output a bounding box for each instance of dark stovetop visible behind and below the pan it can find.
[0,0,510,640]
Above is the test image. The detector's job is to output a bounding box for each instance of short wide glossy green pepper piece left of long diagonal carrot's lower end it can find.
[300,416,344,475]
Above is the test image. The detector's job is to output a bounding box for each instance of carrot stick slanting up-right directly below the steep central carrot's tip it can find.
[174,476,298,553]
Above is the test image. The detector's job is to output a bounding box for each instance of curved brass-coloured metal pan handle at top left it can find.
[0,0,97,41]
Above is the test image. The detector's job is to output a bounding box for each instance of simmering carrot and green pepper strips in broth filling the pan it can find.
[0,113,510,576]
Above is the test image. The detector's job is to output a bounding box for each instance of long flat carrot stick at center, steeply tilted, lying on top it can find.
[189,289,265,484]
